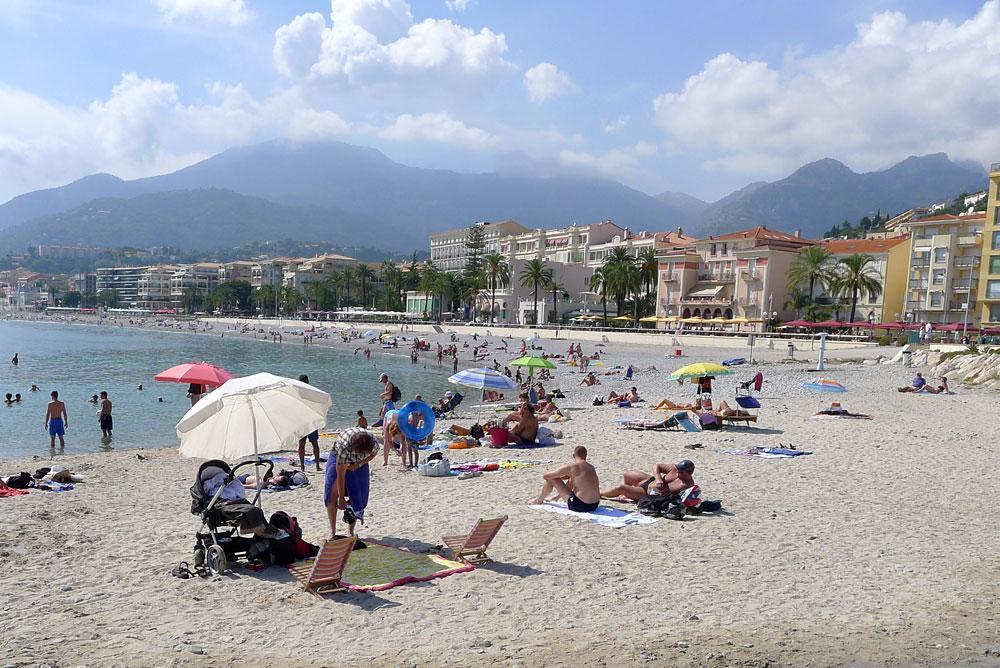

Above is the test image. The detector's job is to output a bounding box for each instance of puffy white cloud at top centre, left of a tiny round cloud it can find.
[274,0,513,88]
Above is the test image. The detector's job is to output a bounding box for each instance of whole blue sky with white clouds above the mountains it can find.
[0,0,1000,201]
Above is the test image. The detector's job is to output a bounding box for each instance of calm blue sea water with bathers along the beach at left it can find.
[0,321,450,459]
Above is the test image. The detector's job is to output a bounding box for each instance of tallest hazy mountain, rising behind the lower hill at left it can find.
[0,141,692,250]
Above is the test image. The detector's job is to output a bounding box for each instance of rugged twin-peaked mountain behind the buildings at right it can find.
[701,153,986,237]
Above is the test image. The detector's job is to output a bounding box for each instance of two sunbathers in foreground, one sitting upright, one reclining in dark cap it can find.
[528,445,694,513]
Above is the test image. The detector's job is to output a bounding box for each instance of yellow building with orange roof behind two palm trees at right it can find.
[821,236,910,322]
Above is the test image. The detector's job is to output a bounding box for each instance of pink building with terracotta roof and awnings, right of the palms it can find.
[657,226,816,319]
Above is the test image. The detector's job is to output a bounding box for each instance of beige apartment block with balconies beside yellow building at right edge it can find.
[900,212,986,323]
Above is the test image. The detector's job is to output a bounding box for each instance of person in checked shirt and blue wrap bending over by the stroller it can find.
[323,427,379,538]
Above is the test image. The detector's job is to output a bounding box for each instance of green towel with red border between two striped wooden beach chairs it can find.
[293,538,475,592]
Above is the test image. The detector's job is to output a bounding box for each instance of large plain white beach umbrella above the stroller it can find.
[177,373,332,461]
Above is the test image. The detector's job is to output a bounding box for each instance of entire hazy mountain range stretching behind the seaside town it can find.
[0,141,985,251]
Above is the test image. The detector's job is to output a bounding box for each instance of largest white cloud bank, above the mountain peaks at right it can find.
[653,0,1000,174]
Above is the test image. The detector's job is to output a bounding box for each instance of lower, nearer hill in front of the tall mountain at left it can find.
[0,189,404,250]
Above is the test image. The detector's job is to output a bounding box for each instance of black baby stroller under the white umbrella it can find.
[191,459,274,573]
